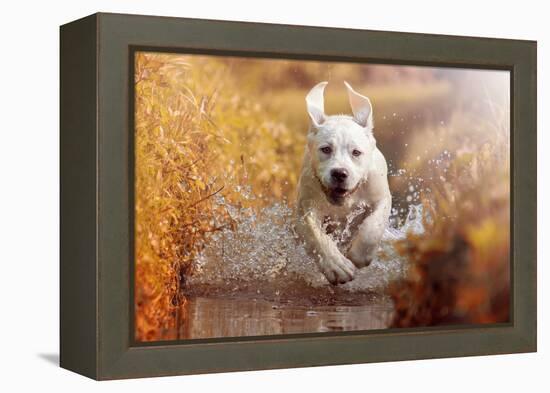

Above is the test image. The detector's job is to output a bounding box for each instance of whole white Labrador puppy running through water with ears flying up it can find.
[296,82,391,284]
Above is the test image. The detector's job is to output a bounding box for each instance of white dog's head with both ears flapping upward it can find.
[306,82,376,205]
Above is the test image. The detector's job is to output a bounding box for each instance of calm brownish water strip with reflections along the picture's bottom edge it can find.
[177,297,393,339]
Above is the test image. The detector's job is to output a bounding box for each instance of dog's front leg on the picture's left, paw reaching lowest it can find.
[296,212,355,285]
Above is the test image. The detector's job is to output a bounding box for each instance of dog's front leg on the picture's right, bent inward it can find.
[347,197,391,268]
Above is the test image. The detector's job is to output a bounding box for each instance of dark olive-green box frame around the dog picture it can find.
[60,14,537,379]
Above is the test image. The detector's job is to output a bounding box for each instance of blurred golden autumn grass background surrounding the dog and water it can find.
[135,53,510,340]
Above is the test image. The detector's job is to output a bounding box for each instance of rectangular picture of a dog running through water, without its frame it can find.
[132,51,511,342]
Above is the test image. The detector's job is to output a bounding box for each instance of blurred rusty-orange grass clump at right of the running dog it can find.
[390,108,511,327]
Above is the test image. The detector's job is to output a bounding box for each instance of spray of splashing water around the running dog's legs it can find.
[187,191,424,300]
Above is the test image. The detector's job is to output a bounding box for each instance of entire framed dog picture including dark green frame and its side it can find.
[60,13,536,379]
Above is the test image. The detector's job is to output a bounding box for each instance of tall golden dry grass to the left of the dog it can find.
[135,53,303,340]
